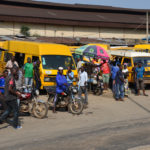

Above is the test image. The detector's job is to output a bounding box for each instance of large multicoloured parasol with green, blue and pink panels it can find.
[75,45,109,59]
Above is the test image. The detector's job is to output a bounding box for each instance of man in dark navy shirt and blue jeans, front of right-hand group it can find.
[115,64,124,101]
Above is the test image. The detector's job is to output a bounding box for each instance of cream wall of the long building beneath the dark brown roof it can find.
[0,22,146,39]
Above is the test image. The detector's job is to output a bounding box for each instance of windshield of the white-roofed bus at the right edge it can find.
[133,57,150,67]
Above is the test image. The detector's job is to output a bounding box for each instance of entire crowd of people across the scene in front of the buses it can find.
[0,56,148,129]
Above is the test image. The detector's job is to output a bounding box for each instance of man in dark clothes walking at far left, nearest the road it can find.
[0,67,22,129]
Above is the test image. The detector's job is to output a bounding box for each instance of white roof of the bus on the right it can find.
[110,50,150,57]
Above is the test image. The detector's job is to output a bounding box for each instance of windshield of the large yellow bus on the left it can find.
[42,55,75,70]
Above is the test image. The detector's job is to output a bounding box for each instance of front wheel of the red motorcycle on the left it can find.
[32,102,48,119]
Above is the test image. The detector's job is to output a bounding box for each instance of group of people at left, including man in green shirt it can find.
[0,56,41,129]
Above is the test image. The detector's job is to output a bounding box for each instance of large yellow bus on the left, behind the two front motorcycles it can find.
[0,41,77,89]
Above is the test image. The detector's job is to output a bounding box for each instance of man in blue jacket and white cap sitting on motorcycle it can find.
[53,67,67,113]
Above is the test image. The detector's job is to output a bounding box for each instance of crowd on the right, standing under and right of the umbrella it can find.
[77,58,148,101]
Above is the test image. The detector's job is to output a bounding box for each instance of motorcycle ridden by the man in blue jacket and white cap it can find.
[46,86,84,115]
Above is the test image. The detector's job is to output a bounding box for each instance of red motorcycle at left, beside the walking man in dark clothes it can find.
[19,86,48,119]
